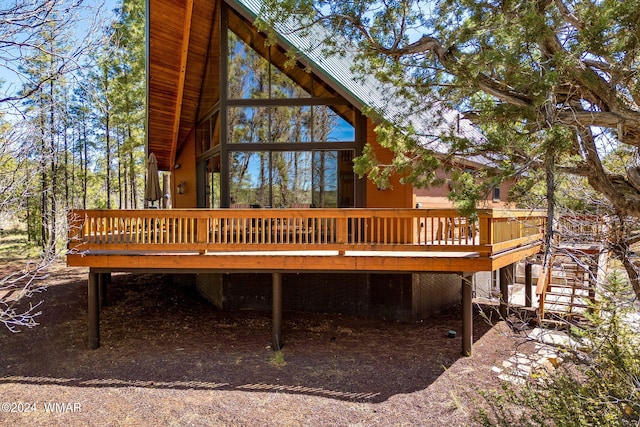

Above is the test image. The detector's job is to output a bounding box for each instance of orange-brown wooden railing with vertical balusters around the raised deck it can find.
[69,208,546,254]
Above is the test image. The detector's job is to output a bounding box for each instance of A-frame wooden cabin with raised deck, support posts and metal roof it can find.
[68,0,545,354]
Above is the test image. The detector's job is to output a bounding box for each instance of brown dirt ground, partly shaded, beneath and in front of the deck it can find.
[0,268,523,426]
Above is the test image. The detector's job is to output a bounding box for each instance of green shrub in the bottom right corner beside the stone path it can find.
[478,273,640,427]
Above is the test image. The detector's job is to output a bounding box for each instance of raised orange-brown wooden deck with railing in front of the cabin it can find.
[67,209,546,272]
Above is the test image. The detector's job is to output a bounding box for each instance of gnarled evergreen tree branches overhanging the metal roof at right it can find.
[260,0,640,216]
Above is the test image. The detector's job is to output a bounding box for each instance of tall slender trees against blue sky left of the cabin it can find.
[0,0,145,332]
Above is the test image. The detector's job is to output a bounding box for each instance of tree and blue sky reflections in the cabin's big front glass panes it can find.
[220,31,356,208]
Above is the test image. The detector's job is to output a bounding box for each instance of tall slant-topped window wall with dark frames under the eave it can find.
[196,13,362,208]
